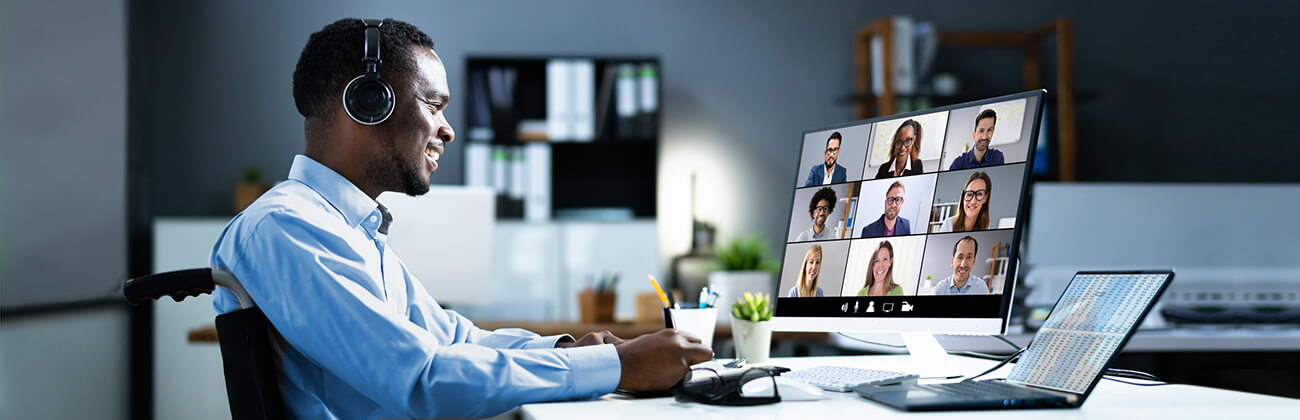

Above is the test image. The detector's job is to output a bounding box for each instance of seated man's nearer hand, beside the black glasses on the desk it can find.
[616,329,714,391]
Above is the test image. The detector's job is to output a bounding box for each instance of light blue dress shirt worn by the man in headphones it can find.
[212,155,621,419]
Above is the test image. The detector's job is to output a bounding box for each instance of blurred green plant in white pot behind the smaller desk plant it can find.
[709,234,779,324]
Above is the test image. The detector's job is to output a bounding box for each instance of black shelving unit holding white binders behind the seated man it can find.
[462,56,662,220]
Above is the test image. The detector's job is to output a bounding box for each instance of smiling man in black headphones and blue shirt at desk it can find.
[212,20,712,419]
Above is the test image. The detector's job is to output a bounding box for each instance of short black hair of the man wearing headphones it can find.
[294,18,433,118]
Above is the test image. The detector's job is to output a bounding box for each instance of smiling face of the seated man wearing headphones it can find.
[369,48,456,195]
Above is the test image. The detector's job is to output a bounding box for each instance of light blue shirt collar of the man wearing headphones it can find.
[289,155,379,230]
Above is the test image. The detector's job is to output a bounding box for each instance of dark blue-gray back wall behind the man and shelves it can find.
[134,0,1300,260]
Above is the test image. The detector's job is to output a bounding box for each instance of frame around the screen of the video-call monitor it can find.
[772,88,1047,334]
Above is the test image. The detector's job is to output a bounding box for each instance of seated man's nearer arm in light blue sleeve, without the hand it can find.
[220,213,623,417]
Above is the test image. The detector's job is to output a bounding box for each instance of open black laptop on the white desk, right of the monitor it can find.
[853,270,1174,411]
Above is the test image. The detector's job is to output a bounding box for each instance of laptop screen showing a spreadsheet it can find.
[1006,272,1173,394]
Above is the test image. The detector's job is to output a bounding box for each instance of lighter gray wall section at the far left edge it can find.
[0,0,126,308]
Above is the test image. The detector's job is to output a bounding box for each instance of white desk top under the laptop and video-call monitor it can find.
[521,356,1300,420]
